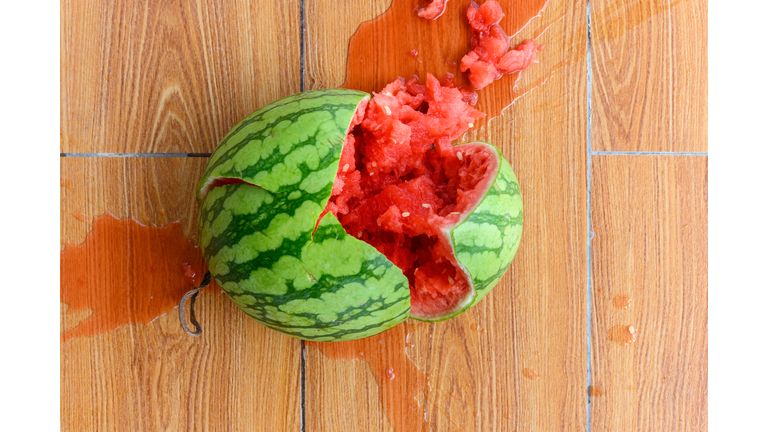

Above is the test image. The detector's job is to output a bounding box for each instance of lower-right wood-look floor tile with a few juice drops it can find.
[592,156,707,432]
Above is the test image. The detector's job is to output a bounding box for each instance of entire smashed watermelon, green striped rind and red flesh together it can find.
[198,75,522,341]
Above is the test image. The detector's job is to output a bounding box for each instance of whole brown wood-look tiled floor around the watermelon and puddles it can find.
[61,0,708,432]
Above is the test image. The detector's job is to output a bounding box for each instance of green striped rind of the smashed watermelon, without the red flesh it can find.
[197,89,522,341]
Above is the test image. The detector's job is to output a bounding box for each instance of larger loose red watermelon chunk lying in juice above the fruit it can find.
[460,0,543,90]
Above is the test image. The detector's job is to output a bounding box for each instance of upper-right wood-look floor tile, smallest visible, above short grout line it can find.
[591,0,707,152]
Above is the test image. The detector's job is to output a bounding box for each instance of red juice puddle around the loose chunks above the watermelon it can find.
[342,0,547,126]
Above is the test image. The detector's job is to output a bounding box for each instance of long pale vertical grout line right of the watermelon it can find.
[586,0,594,432]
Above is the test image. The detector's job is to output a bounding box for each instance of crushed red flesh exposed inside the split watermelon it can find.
[325,75,500,319]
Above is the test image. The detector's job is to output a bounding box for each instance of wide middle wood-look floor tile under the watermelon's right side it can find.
[305,0,588,431]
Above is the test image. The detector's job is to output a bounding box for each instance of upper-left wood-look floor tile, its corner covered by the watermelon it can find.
[61,0,301,153]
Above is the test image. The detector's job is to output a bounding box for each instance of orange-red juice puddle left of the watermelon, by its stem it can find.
[61,213,205,342]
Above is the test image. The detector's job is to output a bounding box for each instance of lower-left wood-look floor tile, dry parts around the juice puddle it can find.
[61,158,301,431]
